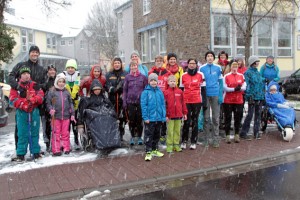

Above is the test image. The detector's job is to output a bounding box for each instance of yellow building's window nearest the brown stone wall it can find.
[213,16,231,55]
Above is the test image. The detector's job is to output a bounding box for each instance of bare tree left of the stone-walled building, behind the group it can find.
[85,0,119,58]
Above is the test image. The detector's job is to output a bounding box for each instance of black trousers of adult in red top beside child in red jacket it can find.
[182,103,202,144]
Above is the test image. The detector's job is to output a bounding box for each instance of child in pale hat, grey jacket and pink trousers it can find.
[47,73,76,156]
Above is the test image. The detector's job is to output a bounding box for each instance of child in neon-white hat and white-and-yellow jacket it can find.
[63,59,80,150]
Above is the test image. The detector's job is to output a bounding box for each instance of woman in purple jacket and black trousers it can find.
[123,61,148,145]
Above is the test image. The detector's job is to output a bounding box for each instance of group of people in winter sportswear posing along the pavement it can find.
[9,46,296,161]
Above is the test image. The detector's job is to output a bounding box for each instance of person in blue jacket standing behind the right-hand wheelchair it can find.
[259,56,280,83]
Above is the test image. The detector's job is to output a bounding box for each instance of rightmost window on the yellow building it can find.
[278,21,292,56]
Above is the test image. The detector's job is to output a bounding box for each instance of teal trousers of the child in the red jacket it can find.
[16,108,41,155]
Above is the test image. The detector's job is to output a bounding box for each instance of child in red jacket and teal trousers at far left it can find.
[10,66,44,162]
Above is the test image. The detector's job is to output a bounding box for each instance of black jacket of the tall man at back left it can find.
[8,60,47,89]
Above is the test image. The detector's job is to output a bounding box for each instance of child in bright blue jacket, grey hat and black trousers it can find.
[141,73,166,161]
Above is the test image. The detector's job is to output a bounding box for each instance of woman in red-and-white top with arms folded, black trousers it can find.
[223,62,246,144]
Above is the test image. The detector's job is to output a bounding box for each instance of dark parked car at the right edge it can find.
[279,69,300,97]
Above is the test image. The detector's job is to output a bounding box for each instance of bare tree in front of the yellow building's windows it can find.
[219,0,298,62]
